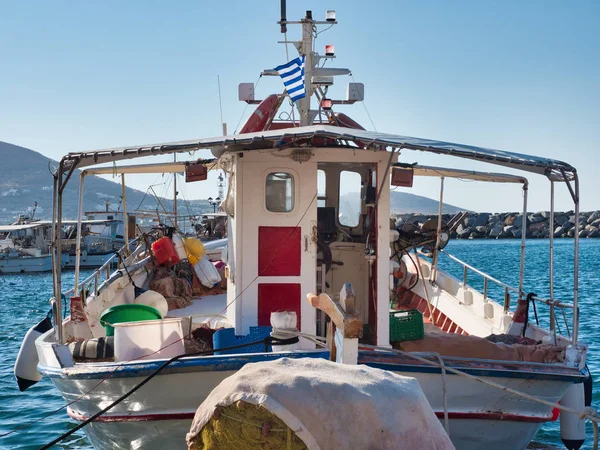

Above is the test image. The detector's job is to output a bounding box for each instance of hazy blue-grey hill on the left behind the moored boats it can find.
[0,141,212,223]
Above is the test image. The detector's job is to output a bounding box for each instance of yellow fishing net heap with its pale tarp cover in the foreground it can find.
[186,358,454,450]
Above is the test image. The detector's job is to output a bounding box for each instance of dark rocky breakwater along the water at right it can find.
[393,211,600,239]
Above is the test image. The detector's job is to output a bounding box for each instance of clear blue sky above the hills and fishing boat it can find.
[0,0,600,211]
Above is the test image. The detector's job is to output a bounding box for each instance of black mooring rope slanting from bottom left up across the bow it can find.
[40,336,298,450]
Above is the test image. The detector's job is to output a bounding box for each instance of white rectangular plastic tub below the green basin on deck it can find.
[114,318,185,361]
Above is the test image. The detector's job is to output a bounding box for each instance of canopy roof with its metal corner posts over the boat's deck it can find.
[52,125,579,345]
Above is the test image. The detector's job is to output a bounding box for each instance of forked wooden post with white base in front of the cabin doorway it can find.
[307,283,363,364]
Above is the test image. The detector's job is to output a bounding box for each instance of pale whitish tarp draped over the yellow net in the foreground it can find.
[187,358,454,450]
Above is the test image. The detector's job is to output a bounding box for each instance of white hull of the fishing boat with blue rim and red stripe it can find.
[38,338,578,450]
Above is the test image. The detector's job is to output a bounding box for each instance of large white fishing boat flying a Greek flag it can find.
[18,6,591,450]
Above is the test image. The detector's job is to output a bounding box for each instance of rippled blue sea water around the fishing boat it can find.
[0,239,600,449]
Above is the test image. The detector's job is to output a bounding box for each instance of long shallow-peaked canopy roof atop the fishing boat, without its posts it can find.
[63,125,576,181]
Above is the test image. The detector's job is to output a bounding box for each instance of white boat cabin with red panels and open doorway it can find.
[221,147,390,344]
